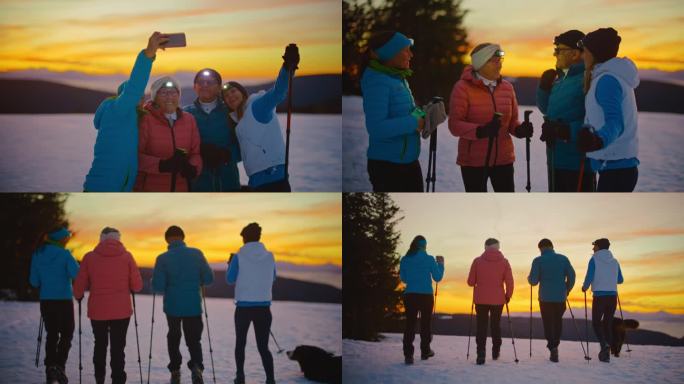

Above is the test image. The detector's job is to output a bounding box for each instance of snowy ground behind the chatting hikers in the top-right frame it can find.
[342,96,684,192]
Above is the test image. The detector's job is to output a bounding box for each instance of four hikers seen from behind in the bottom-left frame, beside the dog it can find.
[30,223,276,384]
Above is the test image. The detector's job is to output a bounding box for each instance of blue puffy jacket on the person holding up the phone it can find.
[83,51,153,192]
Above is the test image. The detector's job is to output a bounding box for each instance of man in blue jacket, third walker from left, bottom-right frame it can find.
[527,239,575,363]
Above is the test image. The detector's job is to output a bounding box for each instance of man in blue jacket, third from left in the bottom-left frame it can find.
[152,225,214,384]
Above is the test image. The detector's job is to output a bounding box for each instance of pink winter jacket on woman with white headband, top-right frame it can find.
[449,65,520,167]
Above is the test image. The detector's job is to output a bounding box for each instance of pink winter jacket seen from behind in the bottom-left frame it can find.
[74,239,142,320]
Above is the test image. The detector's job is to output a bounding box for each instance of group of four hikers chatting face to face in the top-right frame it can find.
[361,28,639,192]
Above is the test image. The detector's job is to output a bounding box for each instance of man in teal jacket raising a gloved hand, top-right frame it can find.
[537,29,596,192]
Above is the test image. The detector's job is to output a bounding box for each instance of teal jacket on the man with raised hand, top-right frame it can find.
[537,63,591,172]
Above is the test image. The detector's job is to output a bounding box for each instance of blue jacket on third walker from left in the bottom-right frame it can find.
[527,249,575,303]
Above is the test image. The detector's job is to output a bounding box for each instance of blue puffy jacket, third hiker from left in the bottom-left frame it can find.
[152,241,214,317]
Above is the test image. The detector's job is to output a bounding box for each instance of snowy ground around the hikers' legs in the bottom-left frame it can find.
[0,295,342,383]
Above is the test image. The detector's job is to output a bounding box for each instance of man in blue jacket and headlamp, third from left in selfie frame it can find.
[183,68,241,192]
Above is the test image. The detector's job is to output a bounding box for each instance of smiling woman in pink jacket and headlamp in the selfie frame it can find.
[134,76,202,192]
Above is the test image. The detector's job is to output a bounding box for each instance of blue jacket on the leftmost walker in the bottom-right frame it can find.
[399,249,444,295]
